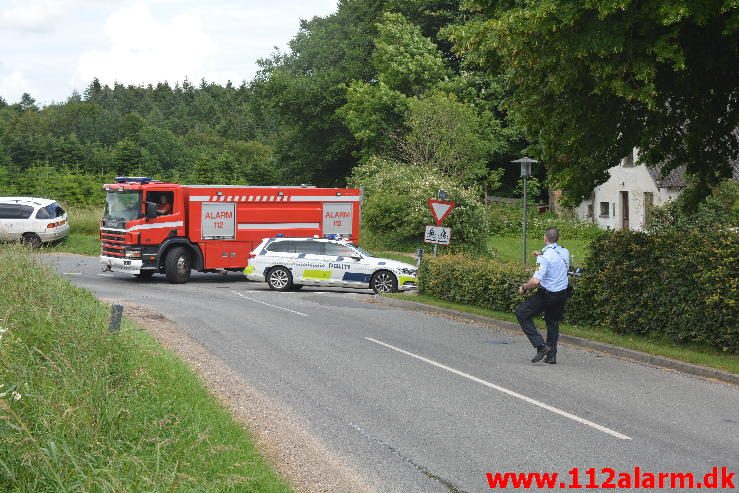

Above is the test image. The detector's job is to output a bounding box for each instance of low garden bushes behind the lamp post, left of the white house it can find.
[487,204,603,241]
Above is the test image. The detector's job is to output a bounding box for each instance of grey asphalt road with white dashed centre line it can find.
[48,256,739,492]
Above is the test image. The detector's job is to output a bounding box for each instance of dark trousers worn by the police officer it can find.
[516,286,567,357]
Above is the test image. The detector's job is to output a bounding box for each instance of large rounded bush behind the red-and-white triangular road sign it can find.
[350,158,487,251]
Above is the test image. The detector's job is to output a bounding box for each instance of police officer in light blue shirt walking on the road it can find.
[516,228,570,365]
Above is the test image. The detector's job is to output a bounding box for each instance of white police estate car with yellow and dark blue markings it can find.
[244,238,418,293]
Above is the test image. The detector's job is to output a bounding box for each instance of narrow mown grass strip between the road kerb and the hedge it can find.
[383,294,739,374]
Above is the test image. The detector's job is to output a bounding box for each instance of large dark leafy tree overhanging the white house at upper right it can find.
[451,0,739,201]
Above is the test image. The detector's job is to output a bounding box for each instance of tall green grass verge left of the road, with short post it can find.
[0,246,290,493]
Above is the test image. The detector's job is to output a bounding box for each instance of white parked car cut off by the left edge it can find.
[0,197,69,248]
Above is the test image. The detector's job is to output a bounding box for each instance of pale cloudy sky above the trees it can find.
[0,0,337,105]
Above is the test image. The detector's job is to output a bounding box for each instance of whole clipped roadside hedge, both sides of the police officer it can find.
[419,228,739,354]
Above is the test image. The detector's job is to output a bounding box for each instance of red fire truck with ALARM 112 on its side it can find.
[100,177,362,284]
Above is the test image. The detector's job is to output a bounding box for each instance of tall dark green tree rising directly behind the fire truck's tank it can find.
[252,0,384,185]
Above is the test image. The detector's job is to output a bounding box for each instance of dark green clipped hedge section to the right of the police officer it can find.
[568,228,739,353]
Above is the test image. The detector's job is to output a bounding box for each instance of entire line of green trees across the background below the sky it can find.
[0,0,739,207]
